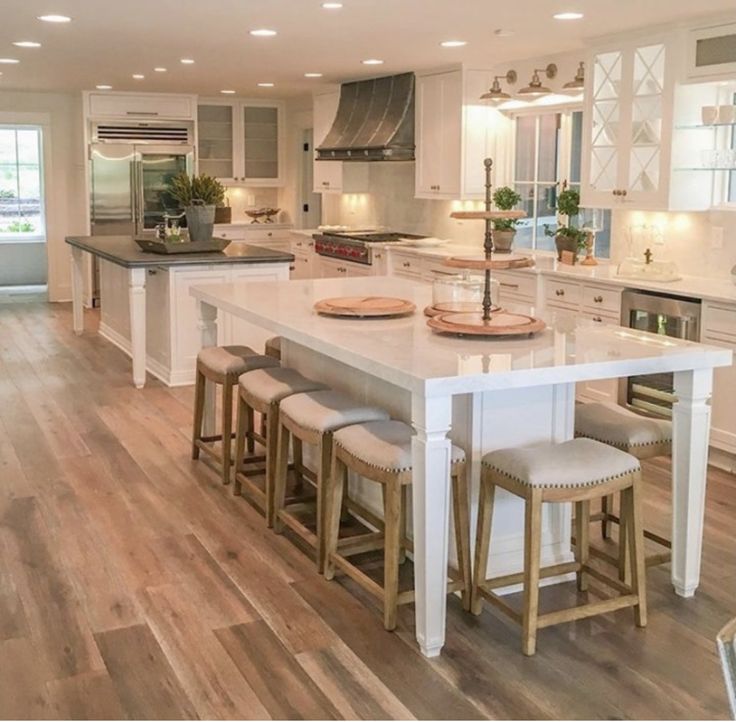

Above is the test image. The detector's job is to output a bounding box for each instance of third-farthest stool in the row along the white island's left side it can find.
[274,389,388,574]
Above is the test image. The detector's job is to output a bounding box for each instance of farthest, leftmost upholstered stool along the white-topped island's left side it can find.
[192,346,279,484]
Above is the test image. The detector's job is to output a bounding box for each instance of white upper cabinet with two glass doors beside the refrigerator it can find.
[197,99,285,187]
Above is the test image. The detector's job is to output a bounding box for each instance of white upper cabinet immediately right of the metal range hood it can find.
[415,68,511,200]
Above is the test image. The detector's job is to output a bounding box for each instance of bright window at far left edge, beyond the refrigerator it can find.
[0,125,46,242]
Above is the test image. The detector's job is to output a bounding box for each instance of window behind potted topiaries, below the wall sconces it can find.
[514,110,611,253]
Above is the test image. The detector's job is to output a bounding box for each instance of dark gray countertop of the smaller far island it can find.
[66,236,294,268]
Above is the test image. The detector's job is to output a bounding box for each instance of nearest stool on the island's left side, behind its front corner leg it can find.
[325,420,471,631]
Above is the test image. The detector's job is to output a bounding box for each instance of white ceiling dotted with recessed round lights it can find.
[0,0,734,97]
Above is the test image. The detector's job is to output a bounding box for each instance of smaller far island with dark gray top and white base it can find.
[66,236,294,388]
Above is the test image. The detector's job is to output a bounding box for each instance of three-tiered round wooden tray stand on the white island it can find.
[427,158,545,336]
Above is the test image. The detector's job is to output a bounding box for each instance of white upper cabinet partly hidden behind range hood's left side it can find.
[312,90,369,193]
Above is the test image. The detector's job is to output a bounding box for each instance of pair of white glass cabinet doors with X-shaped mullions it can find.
[581,38,675,210]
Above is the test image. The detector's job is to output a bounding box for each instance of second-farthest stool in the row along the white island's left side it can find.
[233,367,325,527]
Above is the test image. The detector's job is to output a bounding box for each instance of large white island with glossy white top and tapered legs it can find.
[191,277,731,656]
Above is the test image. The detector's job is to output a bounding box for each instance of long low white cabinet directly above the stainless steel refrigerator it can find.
[85,92,197,120]
